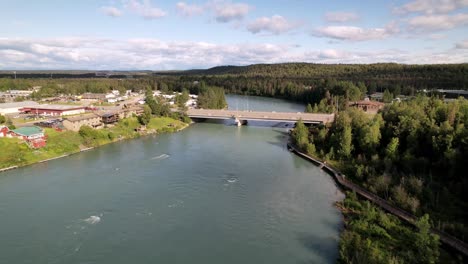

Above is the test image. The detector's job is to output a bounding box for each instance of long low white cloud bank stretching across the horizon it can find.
[0,38,468,70]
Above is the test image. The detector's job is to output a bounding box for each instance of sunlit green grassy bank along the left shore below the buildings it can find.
[0,117,187,169]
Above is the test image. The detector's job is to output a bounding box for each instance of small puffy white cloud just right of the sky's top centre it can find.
[247,15,300,34]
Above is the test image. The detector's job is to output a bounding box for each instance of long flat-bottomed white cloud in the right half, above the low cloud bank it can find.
[312,23,399,41]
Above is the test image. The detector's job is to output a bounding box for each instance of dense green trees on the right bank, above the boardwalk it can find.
[293,96,468,250]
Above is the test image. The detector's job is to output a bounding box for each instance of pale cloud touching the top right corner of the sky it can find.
[395,0,468,15]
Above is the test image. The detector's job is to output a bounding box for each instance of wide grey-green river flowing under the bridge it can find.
[0,96,342,264]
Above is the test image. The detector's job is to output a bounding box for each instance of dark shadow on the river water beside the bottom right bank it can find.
[297,233,339,263]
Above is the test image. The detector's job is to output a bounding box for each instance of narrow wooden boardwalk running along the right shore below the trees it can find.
[288,143,468,257]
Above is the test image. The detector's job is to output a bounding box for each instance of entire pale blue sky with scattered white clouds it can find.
[0,0,468,70]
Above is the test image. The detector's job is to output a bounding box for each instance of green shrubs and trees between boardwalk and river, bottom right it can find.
[337,192,464,264]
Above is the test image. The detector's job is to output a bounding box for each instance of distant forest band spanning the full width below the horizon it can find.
[0,63,468,105]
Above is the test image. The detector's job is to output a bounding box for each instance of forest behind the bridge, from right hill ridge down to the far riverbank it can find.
[162,63,468,103]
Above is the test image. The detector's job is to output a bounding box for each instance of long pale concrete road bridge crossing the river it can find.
[187,109,335,126]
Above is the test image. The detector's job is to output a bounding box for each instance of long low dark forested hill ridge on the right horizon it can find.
[154,63,468,90]
